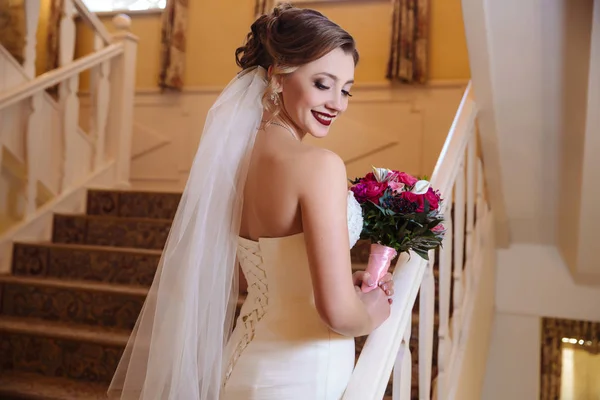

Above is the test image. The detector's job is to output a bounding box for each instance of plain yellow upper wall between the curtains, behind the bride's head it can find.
[63,0,470,88]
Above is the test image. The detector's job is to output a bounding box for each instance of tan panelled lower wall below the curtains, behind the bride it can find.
[80,80,467,191]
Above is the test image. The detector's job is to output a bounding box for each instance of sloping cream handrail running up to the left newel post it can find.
[0,43,123,110]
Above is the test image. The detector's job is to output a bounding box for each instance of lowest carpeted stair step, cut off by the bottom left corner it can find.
[0,372,108,400]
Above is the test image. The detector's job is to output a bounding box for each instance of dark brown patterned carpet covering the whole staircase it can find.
[0,190,450,400]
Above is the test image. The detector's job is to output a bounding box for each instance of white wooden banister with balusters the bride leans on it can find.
[343,85,487,400]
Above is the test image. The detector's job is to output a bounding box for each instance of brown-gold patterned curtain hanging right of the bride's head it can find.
[386,0,429,83]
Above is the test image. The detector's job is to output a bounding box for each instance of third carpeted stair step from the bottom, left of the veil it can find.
[0,276,148,329]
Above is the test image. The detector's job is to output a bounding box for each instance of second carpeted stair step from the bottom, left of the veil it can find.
[0,317,129,386]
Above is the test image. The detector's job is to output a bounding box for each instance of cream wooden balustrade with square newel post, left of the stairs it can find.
[0,0,137,233]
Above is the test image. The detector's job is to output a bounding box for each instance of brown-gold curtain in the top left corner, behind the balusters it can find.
[0,0,26,64]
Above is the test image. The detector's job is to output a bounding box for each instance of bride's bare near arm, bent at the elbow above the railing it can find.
[299,149,390,336]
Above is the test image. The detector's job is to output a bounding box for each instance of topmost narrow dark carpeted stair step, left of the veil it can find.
[87,190,181,220]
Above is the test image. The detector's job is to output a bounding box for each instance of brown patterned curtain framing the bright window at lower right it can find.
[540,318,600,400]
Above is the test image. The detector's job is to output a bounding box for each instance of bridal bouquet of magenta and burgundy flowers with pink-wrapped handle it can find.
[350,167,445,291]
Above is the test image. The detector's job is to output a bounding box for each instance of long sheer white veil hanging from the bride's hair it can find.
[108,67,267,400]
